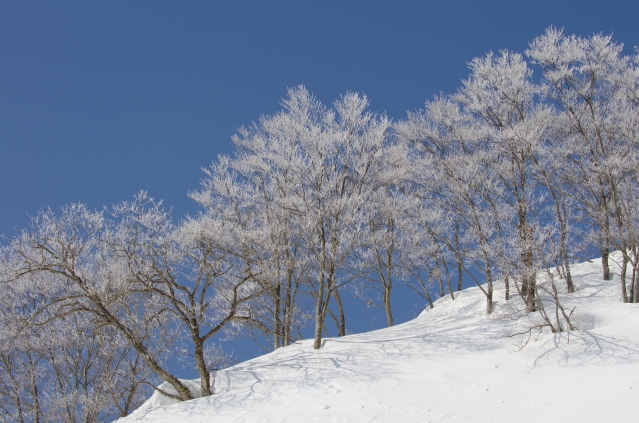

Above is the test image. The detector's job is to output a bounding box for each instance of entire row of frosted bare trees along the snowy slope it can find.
[0,28,639,422]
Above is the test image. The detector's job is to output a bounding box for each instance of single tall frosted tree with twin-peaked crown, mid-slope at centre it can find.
[194,87,404,348]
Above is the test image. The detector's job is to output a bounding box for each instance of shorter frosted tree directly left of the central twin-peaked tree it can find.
[190,156,308,350]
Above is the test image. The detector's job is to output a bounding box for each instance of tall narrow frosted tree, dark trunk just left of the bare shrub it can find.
[455,51,548,310]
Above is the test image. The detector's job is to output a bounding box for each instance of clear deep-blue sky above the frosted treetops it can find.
[0,0,639,370]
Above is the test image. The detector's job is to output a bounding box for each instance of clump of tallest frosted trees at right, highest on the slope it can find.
[395,28,638,313]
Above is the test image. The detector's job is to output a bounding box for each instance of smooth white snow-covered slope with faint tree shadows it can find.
[120,253,639,423]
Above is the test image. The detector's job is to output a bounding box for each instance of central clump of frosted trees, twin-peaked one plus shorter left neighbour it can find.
[192,87,409,348]
